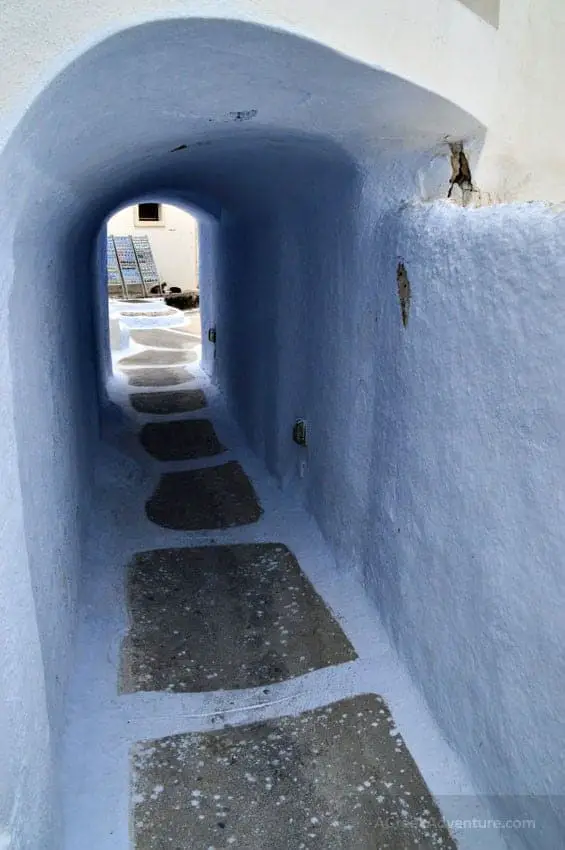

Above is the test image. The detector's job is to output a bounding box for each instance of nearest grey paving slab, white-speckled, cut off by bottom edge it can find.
[132,694,456,850]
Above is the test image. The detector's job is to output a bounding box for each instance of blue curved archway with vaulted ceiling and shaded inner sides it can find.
[0,19,482,847]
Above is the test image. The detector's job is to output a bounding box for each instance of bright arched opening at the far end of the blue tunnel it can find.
[99,198,210,383]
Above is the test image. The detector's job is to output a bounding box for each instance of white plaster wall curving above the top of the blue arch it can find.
[0,0,495,142]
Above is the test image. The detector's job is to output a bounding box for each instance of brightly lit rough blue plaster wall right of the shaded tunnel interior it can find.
[366,205,565,848]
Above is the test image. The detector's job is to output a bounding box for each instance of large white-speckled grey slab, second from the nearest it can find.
[121,543,357,693]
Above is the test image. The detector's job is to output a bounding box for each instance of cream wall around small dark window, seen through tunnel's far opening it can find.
[108,204,198,290]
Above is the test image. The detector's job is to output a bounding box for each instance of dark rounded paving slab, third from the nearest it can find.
[145,461,263,531]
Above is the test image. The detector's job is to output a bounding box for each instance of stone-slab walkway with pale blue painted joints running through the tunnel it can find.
[59,319,470,850]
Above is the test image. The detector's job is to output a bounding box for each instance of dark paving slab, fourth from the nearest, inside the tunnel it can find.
[139,419,226,460]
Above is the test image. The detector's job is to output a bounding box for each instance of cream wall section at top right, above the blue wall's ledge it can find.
[476,0,565,202]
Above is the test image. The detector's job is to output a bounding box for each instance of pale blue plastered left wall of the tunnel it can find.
[0,156,97,850]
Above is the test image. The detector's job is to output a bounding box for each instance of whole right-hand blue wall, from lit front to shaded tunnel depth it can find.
[218,192,565,848]
